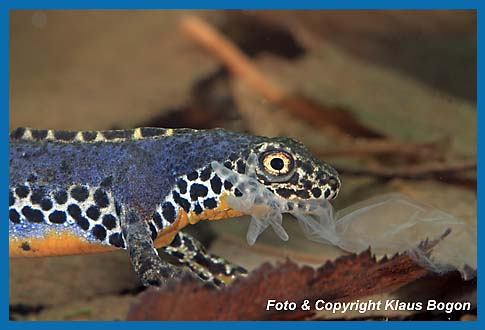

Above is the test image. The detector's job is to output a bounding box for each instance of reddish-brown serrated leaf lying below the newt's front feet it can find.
[128,250,430,320]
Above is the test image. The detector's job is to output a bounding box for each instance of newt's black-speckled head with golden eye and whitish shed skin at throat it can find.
[211,138,341,244]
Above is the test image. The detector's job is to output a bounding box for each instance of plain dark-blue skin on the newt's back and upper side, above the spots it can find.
[10,129,267,217]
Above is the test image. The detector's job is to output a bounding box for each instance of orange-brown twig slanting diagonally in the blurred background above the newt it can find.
[181,16,450,159]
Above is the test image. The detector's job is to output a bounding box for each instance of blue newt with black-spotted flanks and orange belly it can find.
[9,127,341,286]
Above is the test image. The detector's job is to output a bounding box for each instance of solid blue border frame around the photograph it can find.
[0,0,485,329]
